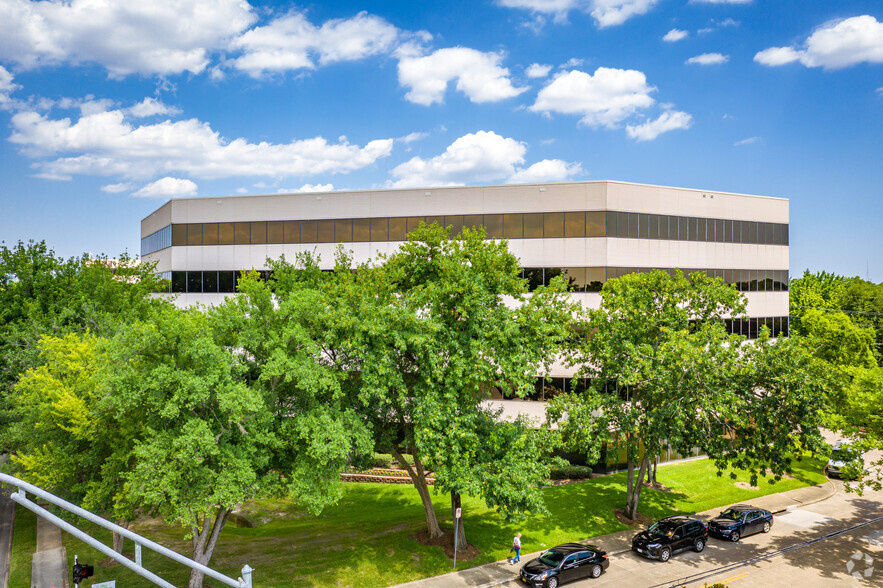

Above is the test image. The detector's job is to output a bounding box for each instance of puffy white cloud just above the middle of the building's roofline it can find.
[388,131,583,188]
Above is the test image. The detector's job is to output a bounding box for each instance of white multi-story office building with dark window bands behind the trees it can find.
[141,181,788,458]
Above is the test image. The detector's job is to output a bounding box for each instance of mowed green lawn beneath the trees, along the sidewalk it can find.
[13,458,825,587]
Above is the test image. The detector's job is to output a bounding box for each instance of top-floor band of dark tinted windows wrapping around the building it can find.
[141,211,788,255]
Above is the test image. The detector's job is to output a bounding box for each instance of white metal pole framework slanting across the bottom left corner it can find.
[0,473,253,588]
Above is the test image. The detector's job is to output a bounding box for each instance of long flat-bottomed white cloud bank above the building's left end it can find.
[10,100,393,179]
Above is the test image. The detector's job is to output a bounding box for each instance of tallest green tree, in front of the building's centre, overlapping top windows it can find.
[326,225,574,543]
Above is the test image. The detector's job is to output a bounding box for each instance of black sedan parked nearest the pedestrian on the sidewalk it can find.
[521,543,610,588]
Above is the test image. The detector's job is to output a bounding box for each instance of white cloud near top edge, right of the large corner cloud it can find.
[231,12,399,76]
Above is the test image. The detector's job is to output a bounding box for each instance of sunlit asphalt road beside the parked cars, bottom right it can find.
[567,482,883,588]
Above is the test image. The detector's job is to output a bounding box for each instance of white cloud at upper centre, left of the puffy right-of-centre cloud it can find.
[399,47,527,106]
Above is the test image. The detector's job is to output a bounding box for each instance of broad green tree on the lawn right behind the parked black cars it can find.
[550,270,821,518]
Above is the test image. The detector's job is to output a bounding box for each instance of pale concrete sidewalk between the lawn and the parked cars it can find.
[398,481,836,588]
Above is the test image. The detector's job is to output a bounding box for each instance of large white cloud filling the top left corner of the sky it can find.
[0,0,255,77]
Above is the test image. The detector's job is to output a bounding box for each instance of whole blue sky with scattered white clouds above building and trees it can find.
[0,0,883,282]
